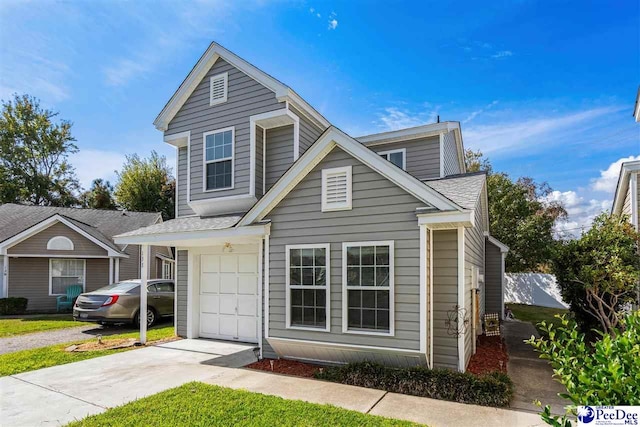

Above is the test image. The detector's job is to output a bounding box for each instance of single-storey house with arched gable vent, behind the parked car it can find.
[0,203,174,311]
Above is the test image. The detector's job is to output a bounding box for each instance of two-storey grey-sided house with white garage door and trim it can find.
[115,43,506,371]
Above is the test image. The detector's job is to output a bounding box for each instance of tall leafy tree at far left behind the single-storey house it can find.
[0,95,80,206]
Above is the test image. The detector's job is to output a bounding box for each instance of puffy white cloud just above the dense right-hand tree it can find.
[546,190,611,237]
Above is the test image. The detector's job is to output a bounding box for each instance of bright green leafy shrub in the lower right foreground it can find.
[528,311,640,426]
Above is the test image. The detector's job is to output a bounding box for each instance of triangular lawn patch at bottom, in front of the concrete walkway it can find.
[69,382,416,427]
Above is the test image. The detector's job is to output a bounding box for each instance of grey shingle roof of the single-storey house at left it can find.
[0,203,160,251]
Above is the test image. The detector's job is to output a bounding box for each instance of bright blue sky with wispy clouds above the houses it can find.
[0,0,640,234]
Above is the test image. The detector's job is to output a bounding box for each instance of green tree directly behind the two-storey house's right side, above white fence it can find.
[465,150,567,272]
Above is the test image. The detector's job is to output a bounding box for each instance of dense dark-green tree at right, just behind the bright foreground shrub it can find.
[552,213,640,332]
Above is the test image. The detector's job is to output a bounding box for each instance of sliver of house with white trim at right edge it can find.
[612,160,640,231]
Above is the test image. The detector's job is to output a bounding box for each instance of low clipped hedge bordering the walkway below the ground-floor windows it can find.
[315,362,513,407]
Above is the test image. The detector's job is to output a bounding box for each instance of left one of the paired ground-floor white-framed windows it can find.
[286,244,330,331]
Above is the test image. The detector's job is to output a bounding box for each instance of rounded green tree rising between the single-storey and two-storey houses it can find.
[114,151,176,219]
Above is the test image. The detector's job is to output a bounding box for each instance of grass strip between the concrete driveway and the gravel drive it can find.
[0,325,174,377]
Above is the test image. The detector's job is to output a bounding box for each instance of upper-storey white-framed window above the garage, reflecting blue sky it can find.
[202,127,234,191]
